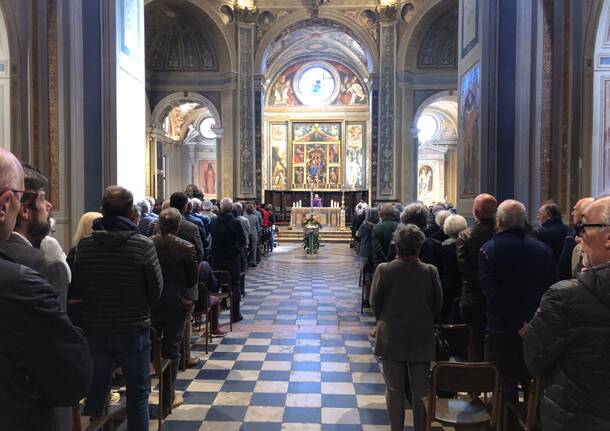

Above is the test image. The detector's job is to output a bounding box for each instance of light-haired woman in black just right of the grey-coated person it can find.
[441,214,468,323]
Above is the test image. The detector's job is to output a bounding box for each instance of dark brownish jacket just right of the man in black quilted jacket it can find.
[151,235,198,308]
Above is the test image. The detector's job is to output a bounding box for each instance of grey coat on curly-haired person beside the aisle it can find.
[370,258,443,362]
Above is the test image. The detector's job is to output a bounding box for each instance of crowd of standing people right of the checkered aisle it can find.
[352,194,610,431]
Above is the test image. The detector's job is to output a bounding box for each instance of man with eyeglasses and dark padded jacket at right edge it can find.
[524,196,610,431]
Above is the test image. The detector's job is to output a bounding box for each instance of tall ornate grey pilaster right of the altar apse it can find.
[376,6,398,201]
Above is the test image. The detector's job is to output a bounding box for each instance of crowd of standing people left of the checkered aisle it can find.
[0,150,274,431]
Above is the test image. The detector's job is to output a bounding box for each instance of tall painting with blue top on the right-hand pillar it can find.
[460,63,481,197]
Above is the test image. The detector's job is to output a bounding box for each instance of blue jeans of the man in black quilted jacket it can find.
[84,329,150,431]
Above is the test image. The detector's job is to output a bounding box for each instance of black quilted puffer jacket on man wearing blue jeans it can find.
[70,219,163,334]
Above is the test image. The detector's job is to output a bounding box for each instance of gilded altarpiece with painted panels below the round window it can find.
[292,123,343,190]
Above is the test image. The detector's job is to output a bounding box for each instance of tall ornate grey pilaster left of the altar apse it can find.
[235,7,256,199]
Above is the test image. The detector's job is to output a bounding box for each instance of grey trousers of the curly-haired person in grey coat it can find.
[382,359,430,431]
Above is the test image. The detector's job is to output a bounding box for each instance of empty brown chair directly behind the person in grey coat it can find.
[422,362,500,431]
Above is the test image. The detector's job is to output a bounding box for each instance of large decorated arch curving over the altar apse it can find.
[254,9,379,75]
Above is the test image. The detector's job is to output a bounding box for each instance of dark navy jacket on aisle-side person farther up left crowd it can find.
[210,213,246,261]
